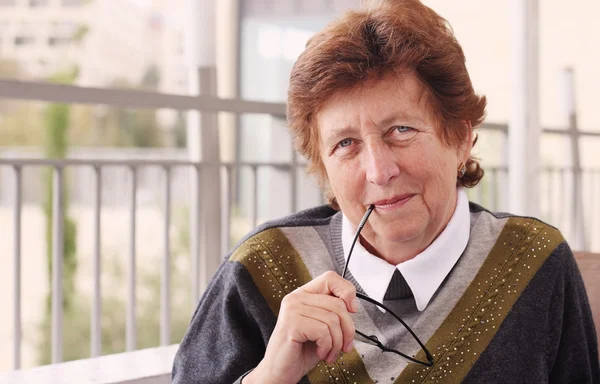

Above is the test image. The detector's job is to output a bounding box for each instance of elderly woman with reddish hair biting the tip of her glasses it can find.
[173,0,600,384]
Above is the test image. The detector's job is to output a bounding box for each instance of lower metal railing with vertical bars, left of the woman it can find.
[0,154,318,369]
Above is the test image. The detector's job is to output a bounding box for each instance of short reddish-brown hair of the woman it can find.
[287,0,486,204]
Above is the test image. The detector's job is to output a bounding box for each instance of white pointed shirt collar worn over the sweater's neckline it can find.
[342,187,471,311]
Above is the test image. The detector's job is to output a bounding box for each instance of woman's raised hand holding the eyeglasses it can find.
[243,271,358,384]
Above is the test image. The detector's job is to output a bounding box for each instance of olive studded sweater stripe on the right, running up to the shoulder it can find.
[395,218,563,384]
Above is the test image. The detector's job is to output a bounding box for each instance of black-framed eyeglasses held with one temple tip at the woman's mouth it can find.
[342,205,433,367]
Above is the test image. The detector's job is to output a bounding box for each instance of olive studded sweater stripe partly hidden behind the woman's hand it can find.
[229,228,373,384]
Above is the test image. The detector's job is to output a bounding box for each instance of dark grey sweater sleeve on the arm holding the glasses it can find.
[172,261,276,384]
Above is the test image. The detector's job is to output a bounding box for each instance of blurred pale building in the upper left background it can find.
[0,0,185,91]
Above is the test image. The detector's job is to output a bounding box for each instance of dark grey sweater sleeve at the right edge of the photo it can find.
[550,243,600,384]
